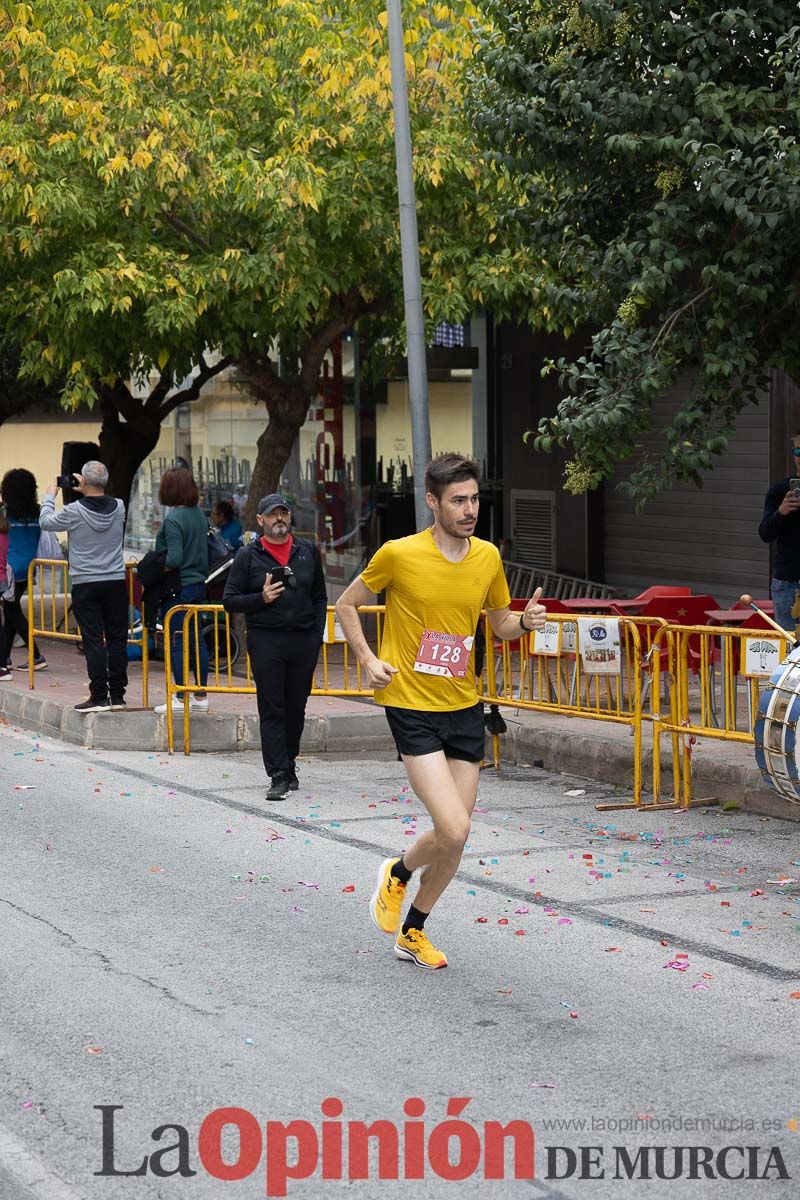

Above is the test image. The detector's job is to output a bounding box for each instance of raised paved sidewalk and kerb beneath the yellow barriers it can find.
[0,642,800,821]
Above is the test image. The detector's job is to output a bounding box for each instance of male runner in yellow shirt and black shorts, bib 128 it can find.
[336,454,546,970]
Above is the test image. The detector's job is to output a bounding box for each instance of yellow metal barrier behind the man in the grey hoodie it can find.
[28,558,150,708]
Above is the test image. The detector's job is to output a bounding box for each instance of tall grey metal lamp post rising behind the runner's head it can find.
[386,0,433,530]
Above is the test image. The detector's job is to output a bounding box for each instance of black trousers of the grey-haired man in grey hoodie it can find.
[72,580,128,701]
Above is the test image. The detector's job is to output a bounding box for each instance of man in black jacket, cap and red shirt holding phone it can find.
[222,493,327,800]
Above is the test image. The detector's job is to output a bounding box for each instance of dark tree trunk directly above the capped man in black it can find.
[242,372,312,529]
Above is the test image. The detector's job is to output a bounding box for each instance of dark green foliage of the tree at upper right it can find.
[471,0,800,499]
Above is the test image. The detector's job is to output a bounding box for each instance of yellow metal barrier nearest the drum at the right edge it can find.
[651,625,793,808]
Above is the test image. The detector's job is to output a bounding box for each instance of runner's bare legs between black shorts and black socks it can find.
[403,750,480,912]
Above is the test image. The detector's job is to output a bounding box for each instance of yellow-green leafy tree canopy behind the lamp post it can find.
[0,0,525,515]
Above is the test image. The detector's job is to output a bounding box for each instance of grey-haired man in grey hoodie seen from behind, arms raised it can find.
[38,462,128,713]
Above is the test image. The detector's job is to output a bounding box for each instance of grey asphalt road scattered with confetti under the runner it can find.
[0,728,800,1200]
